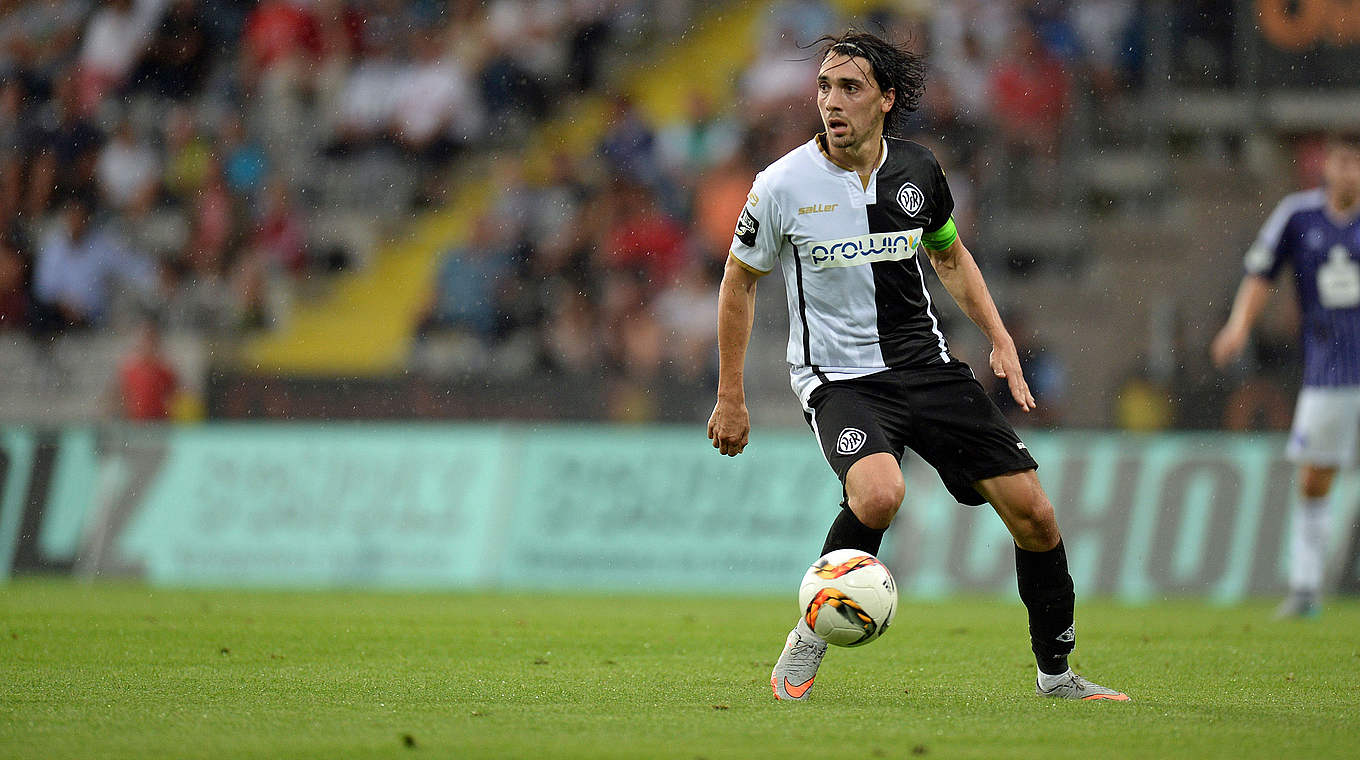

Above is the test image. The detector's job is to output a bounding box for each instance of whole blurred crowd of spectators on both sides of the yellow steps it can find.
[0,0,1213,424]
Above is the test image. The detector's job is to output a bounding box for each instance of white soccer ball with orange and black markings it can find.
[798,549,898,647]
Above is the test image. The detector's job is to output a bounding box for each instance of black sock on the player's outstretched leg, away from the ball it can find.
[1016,540,1077,676]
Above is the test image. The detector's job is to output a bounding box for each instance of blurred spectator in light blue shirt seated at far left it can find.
[33,196,158,329]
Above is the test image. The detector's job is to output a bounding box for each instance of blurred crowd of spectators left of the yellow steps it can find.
[0,0,685,342]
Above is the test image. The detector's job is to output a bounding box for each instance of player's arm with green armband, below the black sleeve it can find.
[925,233,1038,412]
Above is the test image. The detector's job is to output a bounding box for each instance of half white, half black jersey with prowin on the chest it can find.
[732,135,957,408]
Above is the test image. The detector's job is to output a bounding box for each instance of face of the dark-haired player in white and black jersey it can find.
[817,53,895,148]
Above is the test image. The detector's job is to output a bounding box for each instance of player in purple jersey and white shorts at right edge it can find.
[1209,132,1360,617]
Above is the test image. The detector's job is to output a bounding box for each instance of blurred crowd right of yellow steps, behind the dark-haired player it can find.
[413,0,1142,424]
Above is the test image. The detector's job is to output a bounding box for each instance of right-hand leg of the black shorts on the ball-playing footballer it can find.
[907,363,1039,506]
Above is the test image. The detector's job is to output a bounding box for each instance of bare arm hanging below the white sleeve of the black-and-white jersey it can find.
[709,256,760,457]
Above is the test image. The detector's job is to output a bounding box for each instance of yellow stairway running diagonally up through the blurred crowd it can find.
[238,0,872,377]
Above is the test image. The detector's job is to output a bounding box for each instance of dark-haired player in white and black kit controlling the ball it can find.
[709,33,1129,700]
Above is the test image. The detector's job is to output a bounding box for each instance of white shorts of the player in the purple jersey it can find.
[1285,387,1360,469]
